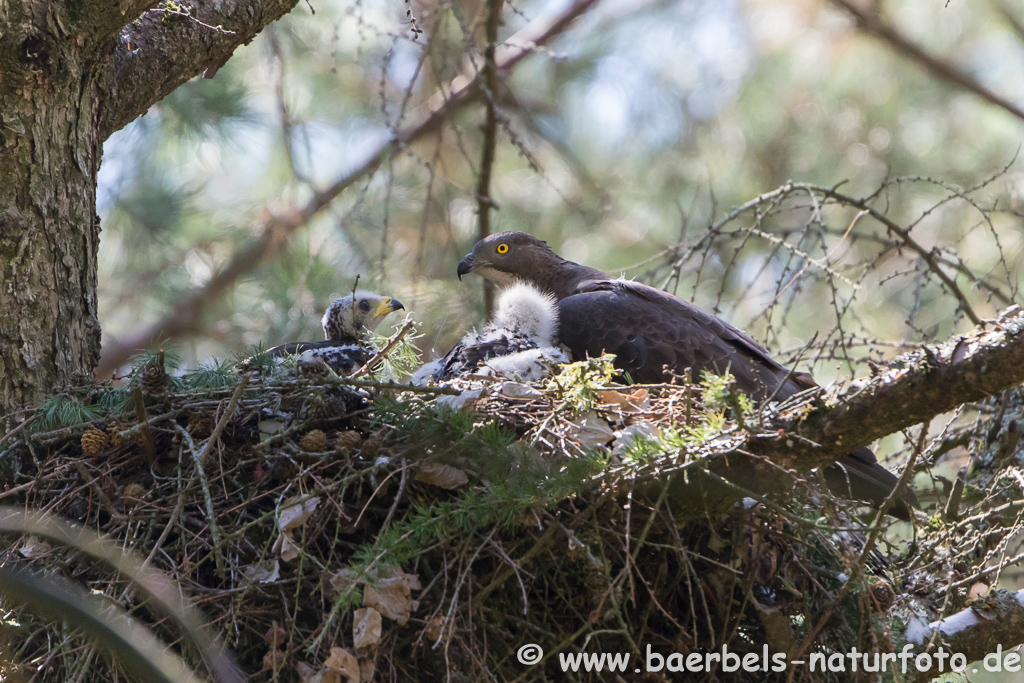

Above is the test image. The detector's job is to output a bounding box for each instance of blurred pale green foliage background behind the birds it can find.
[99,0,1024,379]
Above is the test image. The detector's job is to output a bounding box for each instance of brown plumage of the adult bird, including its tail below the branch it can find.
[458,231,916,519]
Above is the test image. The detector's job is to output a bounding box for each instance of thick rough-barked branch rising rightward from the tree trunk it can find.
[99,0,298,139]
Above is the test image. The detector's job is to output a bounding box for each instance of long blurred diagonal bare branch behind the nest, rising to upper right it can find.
[96,0,597,377]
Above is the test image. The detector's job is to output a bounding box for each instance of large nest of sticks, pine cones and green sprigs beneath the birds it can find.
[0,348,995,683]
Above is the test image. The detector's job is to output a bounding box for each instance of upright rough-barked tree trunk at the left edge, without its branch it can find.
[0,12,102,414]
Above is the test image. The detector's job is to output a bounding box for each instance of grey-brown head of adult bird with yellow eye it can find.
[458,231,561,287]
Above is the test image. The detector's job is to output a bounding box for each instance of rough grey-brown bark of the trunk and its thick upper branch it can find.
[0,0,297,415]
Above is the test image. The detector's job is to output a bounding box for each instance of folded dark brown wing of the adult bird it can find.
[558,279,806,398]
